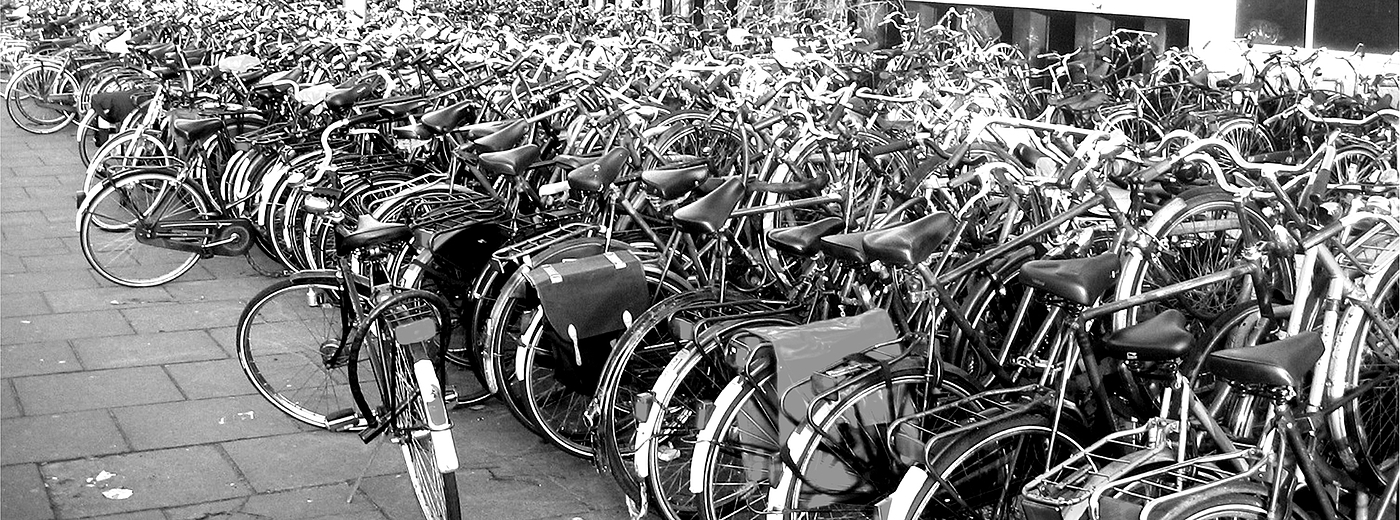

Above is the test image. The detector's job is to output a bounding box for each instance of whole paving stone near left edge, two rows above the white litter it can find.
[13,367,183,415]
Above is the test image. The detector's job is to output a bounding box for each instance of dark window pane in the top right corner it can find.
[1313,0,1400,52]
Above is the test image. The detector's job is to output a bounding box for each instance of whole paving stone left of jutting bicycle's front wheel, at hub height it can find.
[73,331,228,369]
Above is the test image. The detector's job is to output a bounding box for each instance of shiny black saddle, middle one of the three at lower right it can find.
[1203,331,1326,388]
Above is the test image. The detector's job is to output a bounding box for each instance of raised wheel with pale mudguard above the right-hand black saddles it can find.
[1113,188,1292,332]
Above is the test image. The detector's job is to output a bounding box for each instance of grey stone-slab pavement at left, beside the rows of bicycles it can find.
[0,114,627,520]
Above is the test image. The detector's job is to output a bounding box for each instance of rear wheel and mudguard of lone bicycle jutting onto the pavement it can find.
[347,290,462,520]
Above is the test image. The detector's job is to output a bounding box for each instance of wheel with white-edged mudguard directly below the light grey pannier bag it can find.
[769,369,976,519]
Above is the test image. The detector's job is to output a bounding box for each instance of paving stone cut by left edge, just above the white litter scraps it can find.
[0,411,127,463]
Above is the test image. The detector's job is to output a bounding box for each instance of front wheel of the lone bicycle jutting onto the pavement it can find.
[234,276,370,427]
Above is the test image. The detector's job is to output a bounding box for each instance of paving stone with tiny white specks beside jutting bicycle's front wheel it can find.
[112,395,298,450]
